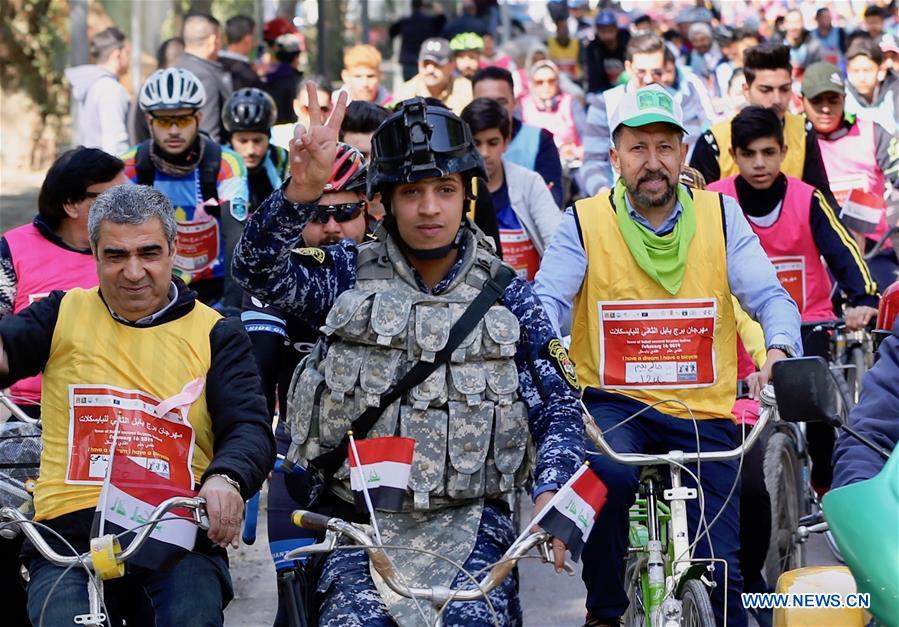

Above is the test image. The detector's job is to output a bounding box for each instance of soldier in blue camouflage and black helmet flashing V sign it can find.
[233,86,584,627]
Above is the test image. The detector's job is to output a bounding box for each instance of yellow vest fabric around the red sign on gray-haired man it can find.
[34,288,221,520]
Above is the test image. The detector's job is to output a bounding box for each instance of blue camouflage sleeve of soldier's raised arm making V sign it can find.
[231,189,357,327]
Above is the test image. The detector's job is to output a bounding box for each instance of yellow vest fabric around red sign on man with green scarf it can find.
[570,190,737,419]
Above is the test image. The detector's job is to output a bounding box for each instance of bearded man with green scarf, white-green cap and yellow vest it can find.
[535,86,801,626]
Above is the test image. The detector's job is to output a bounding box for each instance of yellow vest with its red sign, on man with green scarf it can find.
[571,190,737,418]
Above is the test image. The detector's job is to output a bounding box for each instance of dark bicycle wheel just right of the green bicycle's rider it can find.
[763,432,804,588]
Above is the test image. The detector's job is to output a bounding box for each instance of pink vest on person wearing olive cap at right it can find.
[818,119,887,241]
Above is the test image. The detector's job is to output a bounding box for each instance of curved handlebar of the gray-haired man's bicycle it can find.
[0,496,206,568]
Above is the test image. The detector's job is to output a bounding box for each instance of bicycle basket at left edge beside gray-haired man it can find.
[0,422,41,517]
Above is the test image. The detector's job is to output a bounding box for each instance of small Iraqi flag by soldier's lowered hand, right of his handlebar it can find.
[534,464,608,562]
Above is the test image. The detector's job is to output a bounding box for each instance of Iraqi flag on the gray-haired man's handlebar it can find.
[91,454,197,570]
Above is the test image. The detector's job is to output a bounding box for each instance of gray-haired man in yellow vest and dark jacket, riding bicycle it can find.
[0,185,275,625]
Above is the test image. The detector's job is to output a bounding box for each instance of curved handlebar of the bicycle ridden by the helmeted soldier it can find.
[285,510,549,605]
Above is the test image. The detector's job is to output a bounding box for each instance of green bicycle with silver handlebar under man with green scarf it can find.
[584,385,777,627]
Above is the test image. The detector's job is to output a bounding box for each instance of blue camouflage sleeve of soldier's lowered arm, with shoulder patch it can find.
[503,278,584,494]
